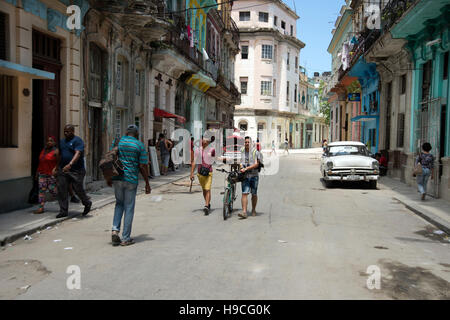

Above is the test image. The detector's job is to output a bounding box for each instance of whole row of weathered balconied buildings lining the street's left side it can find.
[0,0,240,215]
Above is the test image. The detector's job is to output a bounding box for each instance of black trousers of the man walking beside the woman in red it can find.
[56,169,91,213]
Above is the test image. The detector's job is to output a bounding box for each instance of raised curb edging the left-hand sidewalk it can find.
[0,173,190,247]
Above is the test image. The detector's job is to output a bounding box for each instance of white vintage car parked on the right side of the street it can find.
[320,141,380,189]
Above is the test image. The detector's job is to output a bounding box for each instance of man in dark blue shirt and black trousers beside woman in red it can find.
[55,124,92,218]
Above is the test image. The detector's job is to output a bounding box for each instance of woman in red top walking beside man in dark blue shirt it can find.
[34,136,59,214]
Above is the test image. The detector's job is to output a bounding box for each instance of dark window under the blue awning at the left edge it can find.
[0,75,17,148]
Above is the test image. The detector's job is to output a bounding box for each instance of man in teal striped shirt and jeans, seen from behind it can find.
[108,124,151,246]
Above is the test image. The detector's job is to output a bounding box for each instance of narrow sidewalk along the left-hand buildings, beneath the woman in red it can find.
[0,167,190,246]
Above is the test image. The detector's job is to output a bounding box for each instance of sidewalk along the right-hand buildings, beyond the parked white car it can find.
[379,176,450,234]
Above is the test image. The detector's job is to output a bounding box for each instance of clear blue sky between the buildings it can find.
[290,0,345,76]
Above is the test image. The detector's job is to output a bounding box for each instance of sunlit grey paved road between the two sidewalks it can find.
[0,154,450,299]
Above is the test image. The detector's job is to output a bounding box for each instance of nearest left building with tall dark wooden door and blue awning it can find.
[0,0,89,212]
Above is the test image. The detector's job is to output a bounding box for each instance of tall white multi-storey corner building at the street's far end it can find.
[232,0,305,148]
